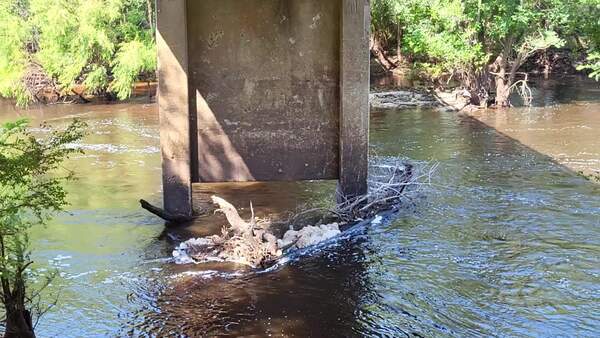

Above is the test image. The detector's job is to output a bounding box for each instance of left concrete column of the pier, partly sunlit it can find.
[156,0,192,216]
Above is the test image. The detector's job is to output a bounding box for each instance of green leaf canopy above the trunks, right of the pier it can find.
[372,0,600,80]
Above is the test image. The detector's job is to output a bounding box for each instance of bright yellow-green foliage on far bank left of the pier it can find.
[0,0,156,104]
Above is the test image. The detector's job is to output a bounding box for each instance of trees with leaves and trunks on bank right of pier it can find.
[371,0,600,106]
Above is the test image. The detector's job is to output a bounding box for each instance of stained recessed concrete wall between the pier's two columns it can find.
[188,0,342,182]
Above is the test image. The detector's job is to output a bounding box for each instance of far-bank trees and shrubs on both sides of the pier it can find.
[0,0,600,108]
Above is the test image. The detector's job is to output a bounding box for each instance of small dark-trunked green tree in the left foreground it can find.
[0,120,85,338]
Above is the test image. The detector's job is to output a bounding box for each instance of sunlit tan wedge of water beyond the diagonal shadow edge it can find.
[472,77,600,175]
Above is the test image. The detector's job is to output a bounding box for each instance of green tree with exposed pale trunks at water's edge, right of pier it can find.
[465,0,570,107]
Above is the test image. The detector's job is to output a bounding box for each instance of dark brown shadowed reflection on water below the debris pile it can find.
[126,238,378,336]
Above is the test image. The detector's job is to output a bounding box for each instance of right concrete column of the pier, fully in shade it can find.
[339,0,371,197]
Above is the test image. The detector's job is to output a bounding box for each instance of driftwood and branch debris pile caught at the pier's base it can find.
[173,163,435,268]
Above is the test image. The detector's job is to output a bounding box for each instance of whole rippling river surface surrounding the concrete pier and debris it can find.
[0,78,600,337]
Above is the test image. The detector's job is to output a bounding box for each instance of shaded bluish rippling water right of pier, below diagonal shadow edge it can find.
[370,105,600,336]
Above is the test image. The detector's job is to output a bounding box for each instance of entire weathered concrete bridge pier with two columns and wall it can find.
[157,0,370,216]
